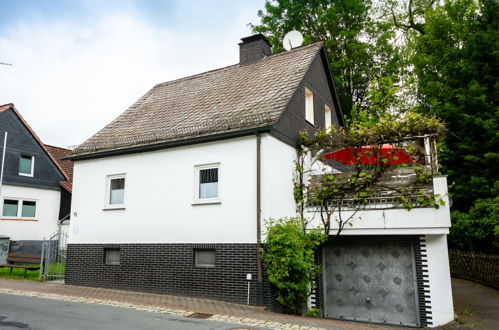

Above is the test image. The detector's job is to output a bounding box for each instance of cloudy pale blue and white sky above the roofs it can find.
[0,0,264,147]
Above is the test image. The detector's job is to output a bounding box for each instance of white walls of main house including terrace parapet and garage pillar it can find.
[69,134,453,326]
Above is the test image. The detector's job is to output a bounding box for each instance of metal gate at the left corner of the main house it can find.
[40,230,68,281]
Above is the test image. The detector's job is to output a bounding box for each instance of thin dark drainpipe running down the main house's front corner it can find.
[256,132,263,306]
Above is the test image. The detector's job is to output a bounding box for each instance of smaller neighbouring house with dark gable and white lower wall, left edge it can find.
[0,104,72,253]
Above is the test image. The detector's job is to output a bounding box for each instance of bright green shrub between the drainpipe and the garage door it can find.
[263,218,326,314]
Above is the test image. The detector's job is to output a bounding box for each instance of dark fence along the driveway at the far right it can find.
[449,250,499,289]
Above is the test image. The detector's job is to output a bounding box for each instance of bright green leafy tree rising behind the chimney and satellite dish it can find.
[252,0,402,115]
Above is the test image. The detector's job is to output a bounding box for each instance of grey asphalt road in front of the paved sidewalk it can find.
[0,294,264,330]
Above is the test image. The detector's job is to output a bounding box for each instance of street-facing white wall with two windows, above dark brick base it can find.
[70,136,276,243]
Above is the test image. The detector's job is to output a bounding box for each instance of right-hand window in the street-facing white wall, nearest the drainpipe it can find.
[194,164,220,203]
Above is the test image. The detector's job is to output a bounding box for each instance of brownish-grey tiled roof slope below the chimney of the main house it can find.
[73,43,322,155]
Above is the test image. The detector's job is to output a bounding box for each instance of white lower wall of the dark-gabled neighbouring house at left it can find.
[0,184,61,241]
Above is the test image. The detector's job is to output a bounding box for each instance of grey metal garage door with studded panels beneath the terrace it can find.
[324,237,420,326]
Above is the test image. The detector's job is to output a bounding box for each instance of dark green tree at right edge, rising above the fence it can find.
[409,0,499,210]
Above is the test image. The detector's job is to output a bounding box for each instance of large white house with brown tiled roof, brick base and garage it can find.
[66,35,453,325]
